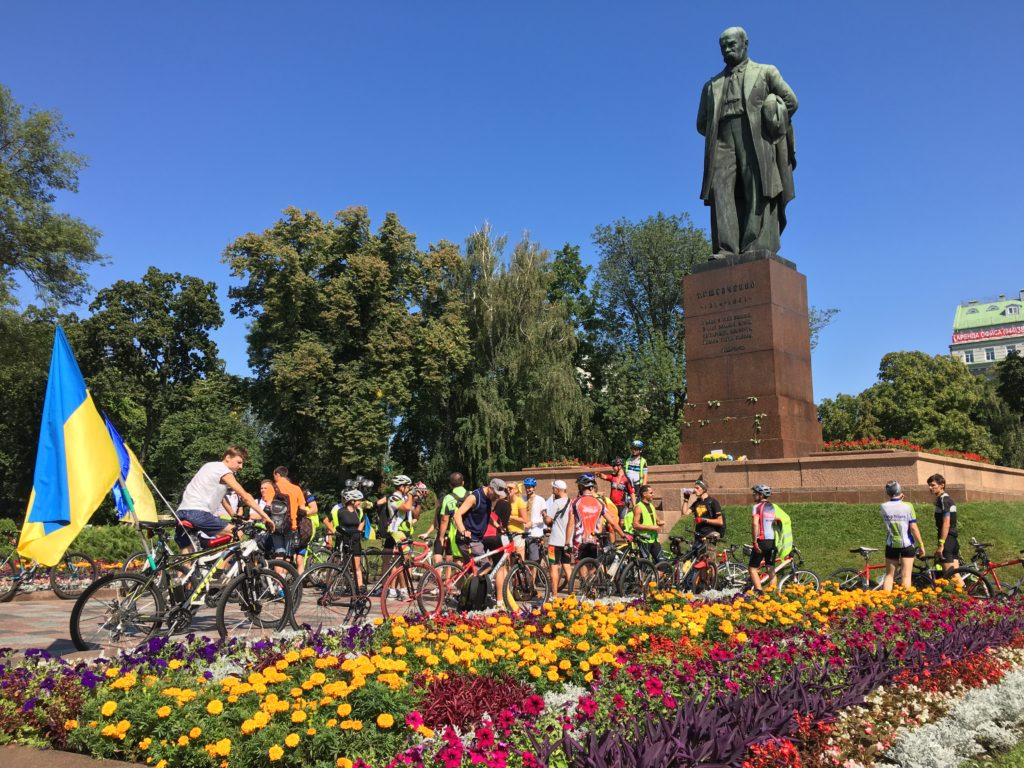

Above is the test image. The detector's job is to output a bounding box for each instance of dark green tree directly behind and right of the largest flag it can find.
[79,267,223,465]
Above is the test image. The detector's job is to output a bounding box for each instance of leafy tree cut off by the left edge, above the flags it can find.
[0,85,102,304]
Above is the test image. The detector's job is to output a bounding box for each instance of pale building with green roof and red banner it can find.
[949,291,1024,371]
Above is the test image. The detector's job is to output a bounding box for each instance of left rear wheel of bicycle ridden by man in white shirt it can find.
[71,573,164,650]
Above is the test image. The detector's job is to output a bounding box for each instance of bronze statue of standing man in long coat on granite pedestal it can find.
[697,27,797,258]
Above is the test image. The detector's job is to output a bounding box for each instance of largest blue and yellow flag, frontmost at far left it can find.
[17,326,120,565]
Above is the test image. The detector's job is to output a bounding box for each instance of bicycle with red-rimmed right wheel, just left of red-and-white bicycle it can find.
[291,539,443,631]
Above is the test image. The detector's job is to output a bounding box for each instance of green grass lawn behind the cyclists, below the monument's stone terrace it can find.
[672,502,1024,585]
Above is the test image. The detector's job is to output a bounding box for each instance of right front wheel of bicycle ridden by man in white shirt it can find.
[217,568,292,640]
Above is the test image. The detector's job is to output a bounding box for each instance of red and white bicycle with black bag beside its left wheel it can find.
[434,532,551,612]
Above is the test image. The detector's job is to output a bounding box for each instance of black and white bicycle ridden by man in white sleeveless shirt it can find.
[71,519,292,650]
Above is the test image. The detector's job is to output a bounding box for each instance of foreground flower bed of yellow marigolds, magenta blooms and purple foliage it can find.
[0,586,1024,768]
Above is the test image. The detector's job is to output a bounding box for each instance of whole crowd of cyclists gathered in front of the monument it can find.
[167,440,959,614]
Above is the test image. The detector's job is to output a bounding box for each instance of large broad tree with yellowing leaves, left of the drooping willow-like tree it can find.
[224,208,464,489]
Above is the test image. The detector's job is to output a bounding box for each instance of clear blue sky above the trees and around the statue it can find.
[0,0,1024,399]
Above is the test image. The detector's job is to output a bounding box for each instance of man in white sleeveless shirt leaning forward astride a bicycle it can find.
[174,445,273,552]
